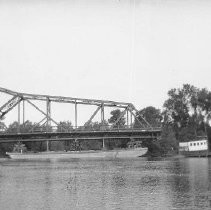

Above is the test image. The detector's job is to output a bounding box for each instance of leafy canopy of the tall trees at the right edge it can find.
[162,84,211,141]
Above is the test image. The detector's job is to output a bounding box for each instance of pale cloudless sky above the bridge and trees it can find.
[0,0,211,124]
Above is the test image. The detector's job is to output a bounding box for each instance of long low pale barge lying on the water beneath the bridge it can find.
[6,142,148,160]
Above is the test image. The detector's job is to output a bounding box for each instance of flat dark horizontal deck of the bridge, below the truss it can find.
[0,129,161,143]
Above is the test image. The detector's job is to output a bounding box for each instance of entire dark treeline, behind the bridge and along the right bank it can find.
[0,84,211,155]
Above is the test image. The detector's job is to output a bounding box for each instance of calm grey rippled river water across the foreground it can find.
[0,158,211,210]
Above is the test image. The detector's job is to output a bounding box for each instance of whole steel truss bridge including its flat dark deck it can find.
[0,88,161,148]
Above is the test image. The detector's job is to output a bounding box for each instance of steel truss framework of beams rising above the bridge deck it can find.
[0,88,153,131]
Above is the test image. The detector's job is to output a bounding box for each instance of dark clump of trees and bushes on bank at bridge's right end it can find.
[142,84,211,155]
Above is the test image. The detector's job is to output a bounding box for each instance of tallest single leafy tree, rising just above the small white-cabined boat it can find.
[163,84,199,141]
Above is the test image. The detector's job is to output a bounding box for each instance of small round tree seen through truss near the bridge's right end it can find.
[108,109,126,128]
